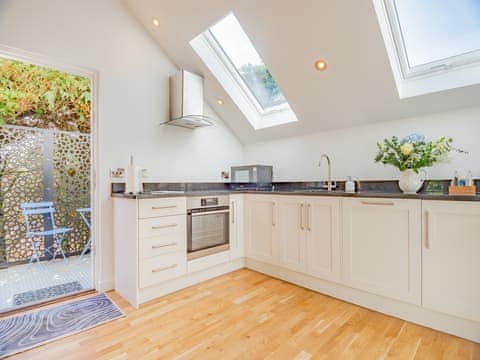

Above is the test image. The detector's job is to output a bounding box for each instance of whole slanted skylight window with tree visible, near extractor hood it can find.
[190,13,297,129]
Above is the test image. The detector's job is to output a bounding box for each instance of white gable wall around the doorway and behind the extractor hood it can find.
[0,0,243,287]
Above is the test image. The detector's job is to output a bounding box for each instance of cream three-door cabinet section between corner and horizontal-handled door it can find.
[246,195,341,281]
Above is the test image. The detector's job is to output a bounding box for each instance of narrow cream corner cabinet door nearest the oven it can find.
[245,196,276,263]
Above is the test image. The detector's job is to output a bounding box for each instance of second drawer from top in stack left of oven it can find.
[138,215,187,240]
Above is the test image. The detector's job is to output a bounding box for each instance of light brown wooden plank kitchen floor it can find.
[14,270,480,360]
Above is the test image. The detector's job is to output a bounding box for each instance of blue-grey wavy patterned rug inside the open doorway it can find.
[0,294,125,358]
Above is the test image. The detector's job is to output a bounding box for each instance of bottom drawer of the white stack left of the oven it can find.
[140,251,187,288]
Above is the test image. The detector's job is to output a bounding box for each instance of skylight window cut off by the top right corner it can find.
[374,0,480,97]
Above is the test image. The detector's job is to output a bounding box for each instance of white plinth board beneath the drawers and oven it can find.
[139,258,245,304]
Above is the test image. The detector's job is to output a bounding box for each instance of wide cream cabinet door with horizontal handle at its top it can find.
[342,198,421,305]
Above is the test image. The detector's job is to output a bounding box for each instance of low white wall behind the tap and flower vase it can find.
[245,108,480,181]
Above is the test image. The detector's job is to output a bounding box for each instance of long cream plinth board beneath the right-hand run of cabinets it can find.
[245,259,480,343]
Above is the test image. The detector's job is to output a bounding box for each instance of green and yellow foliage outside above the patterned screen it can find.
[0,58,91,133]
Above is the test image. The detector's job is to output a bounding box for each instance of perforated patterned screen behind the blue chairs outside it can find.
[0,126,90,263]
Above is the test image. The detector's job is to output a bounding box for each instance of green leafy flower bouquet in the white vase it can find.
[375,134,465,173]
